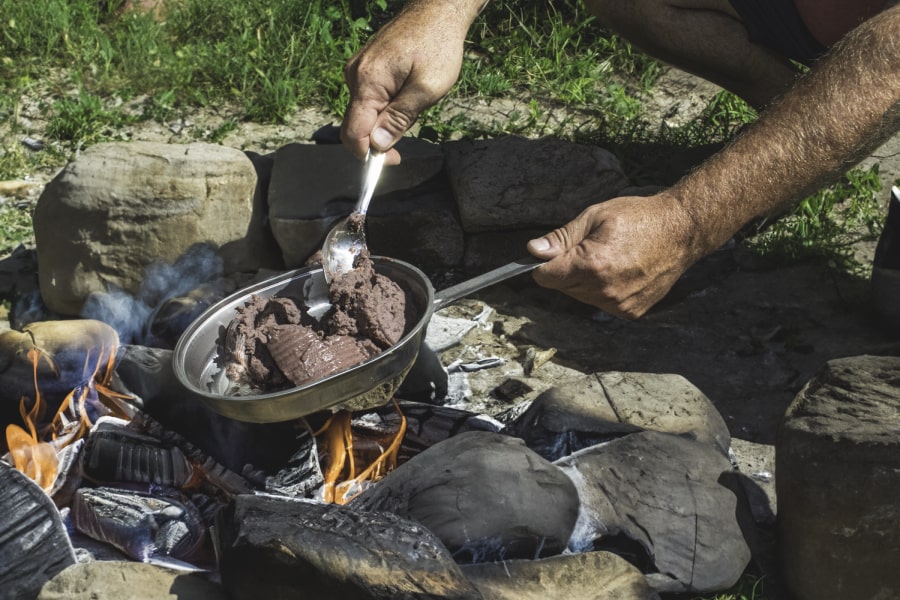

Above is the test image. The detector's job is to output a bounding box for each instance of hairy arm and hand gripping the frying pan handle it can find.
[528,7,900,318]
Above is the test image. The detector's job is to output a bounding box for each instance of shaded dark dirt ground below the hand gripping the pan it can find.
[477,244,900,445]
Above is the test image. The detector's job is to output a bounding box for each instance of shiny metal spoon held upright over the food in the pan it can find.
[322,148,385,283]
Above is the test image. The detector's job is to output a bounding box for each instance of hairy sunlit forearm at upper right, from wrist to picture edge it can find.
[670,7,900,258]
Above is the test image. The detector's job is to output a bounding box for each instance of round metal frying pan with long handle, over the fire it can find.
[173,256,542,423]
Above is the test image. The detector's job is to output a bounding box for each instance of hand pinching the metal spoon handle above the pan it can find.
[341,2,474,164]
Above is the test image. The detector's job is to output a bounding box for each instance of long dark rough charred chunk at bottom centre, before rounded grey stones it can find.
[216,495,481,600]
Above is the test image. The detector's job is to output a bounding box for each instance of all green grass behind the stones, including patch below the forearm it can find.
[0,0,879,272]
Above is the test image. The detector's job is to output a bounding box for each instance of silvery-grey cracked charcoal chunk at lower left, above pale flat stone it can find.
[72,488,206,561]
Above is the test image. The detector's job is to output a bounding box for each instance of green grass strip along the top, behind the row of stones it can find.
[0,0,658,147]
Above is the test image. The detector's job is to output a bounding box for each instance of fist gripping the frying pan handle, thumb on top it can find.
[528,192,700,319]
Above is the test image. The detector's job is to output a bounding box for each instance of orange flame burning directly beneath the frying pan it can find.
[314,400,406,504]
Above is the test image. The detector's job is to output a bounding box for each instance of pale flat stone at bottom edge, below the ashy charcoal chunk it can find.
[37,561,227,600]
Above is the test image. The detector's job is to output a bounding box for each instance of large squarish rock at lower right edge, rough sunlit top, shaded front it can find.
[775,356,900,600]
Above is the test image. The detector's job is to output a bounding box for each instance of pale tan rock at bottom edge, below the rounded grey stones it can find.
[462,552,659,600]
